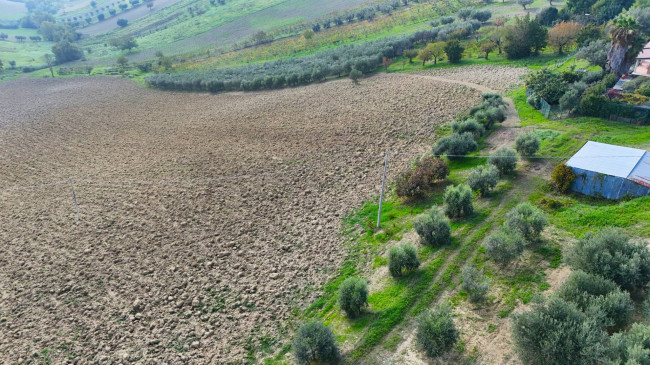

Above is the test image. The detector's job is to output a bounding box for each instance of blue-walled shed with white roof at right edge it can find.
[567,141,650,199]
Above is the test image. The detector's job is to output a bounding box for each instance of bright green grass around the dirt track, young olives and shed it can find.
[260,74,650,362]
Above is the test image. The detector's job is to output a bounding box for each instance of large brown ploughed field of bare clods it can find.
[0,74,488,363]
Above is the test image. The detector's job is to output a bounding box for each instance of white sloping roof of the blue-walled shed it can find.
[567,141,650,179]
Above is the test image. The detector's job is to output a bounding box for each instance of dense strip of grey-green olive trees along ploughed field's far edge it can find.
[146,16,480,92]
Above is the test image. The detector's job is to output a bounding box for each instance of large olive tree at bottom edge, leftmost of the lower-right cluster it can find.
[512,298,607,365]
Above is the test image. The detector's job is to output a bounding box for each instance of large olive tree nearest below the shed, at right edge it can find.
[565,228,650,290]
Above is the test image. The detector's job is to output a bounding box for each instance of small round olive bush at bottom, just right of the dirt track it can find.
[415,306,459,357]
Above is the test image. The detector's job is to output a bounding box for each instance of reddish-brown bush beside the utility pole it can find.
[395,156,449,198]
